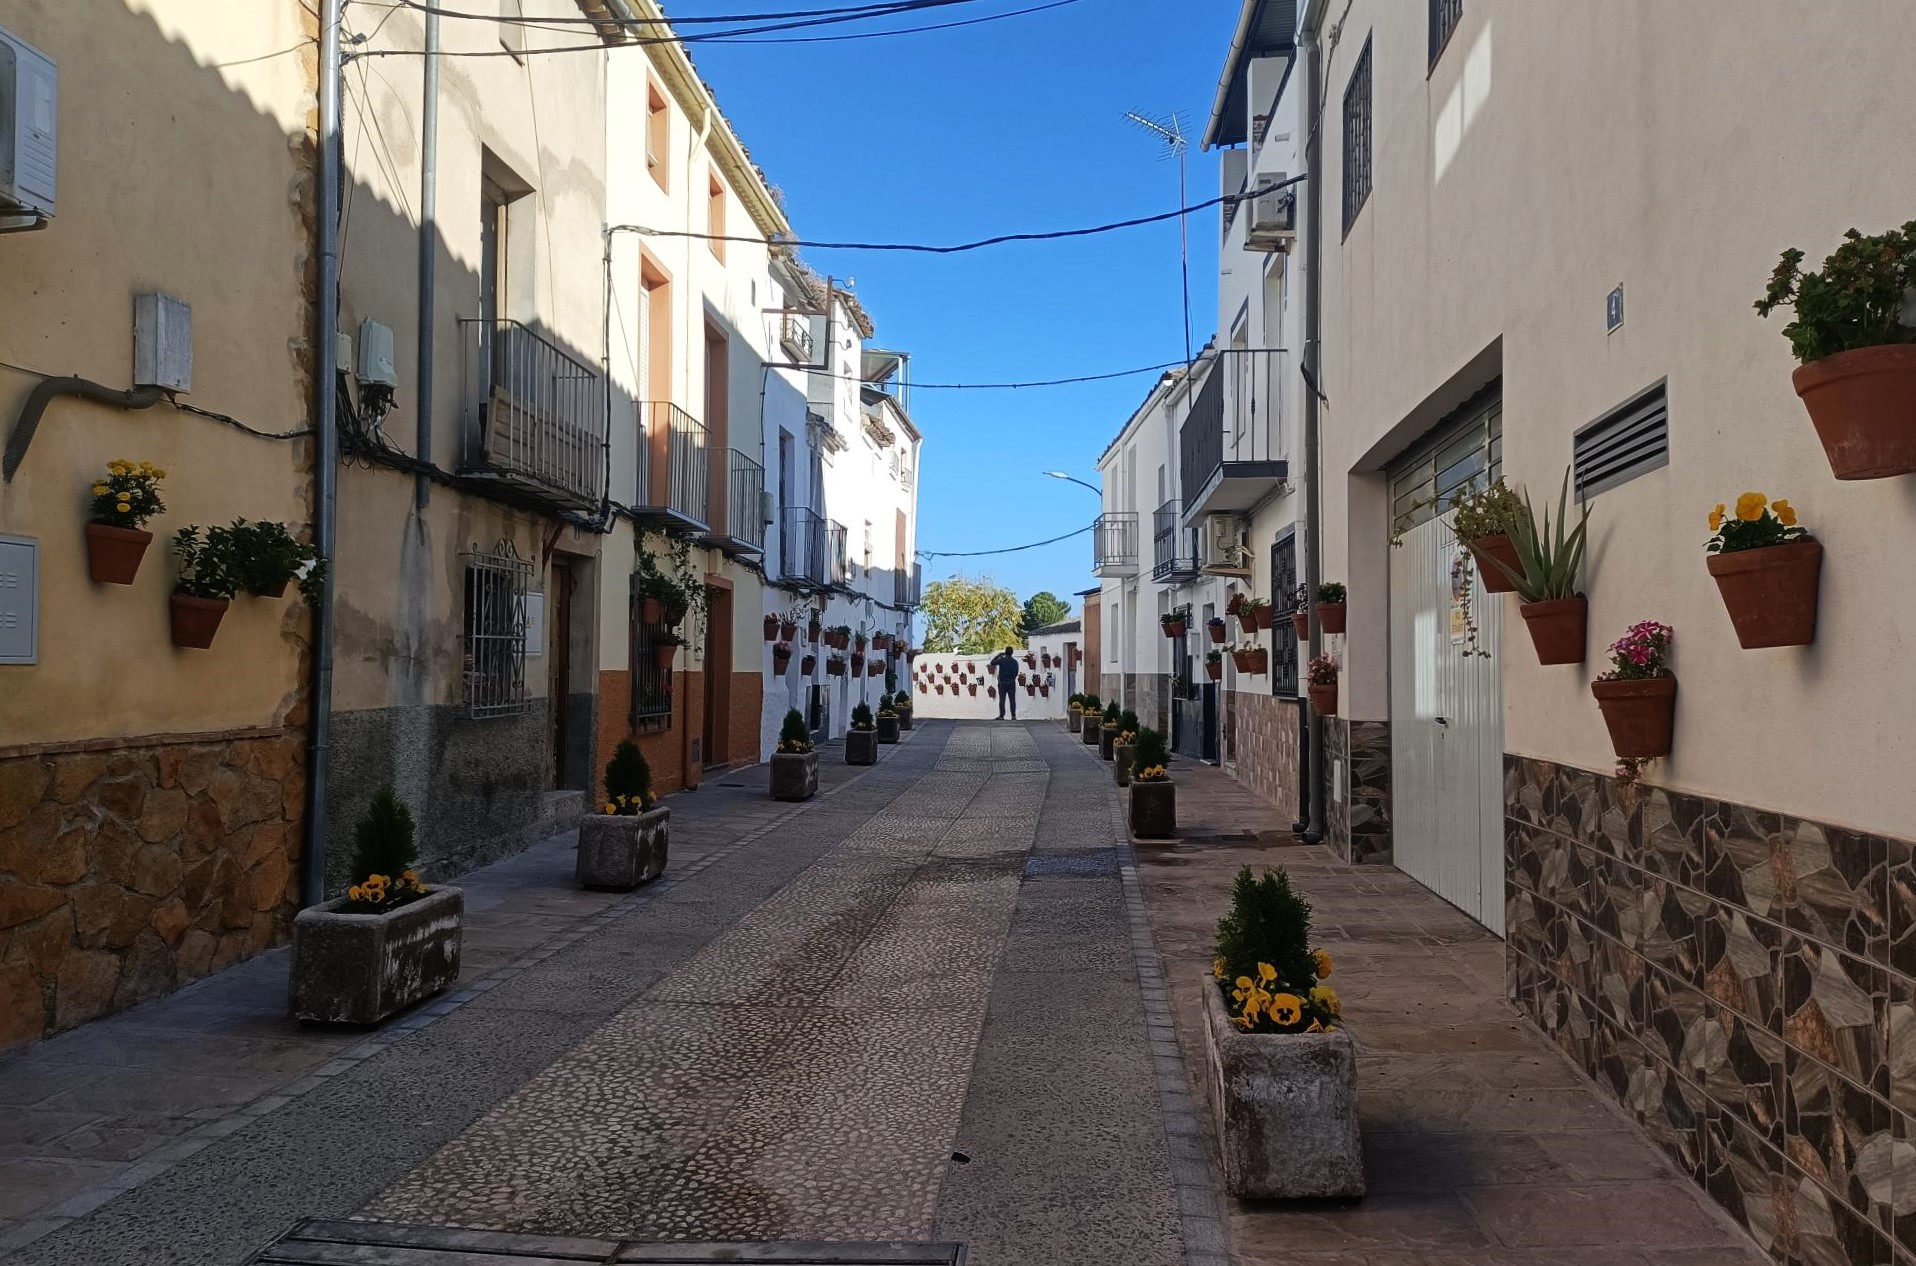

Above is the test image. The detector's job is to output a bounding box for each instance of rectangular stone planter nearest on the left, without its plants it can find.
[291,889,466,1025]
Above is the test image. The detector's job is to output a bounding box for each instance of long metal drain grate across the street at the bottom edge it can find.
[253,1218,964,1266]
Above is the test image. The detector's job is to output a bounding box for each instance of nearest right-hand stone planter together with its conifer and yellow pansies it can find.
[1203,868,1364,1199]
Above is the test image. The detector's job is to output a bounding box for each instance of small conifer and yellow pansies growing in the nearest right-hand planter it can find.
[1211,866,1343,1032]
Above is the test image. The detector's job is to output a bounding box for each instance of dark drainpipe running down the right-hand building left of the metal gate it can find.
[1299,23,1330,845]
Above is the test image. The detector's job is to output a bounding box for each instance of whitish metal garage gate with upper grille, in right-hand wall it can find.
[1391,393,1504,935]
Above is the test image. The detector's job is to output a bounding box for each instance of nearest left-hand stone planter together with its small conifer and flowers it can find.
[291,787,466,1025]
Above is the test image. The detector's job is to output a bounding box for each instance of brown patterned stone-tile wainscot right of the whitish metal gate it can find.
[1504,757,1916,1266]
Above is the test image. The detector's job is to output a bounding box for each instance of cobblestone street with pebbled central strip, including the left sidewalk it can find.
[0,722,1195,1266]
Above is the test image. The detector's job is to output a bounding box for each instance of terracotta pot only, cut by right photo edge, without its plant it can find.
[1791,343,1916,479]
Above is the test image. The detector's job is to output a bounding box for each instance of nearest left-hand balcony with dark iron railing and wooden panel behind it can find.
[460,320,605,511]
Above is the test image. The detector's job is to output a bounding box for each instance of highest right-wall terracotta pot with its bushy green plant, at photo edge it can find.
[1755,220,1916,479]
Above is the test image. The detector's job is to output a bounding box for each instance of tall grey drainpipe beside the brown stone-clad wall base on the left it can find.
[299,0,343,906]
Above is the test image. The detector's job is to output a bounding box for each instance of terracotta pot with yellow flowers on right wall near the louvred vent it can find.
[1705,492,1822,651]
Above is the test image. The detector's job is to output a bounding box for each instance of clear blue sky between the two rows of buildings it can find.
[689,0,1238,612]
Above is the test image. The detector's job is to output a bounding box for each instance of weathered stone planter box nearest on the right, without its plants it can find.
[1201,981,1364,1199]
